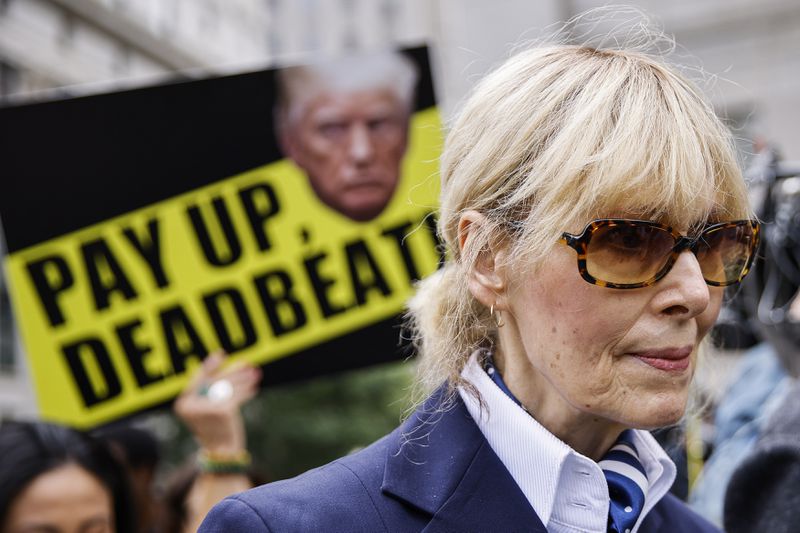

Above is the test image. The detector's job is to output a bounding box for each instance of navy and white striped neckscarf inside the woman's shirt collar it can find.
[482,353,649,533]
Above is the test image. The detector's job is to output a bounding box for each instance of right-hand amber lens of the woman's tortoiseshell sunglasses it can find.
[695,222,756,285]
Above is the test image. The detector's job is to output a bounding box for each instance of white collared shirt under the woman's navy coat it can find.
[459,352,675,533]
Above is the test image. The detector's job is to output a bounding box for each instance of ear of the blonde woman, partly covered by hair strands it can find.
[458,210,507,310]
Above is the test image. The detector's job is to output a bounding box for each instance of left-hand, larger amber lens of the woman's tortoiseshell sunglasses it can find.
[586,222,675,285]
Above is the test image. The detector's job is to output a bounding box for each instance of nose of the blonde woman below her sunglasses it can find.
[658,250,711,318]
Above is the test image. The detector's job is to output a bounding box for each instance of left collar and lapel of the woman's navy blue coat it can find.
[381,386,546,533]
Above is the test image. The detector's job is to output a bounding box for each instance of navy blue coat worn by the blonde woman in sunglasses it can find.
[200,386,719,533]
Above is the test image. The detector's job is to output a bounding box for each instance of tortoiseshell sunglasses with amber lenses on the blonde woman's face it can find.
[559,218,760,289]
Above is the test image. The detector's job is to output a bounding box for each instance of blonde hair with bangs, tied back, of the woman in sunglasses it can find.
[408,21,751,404]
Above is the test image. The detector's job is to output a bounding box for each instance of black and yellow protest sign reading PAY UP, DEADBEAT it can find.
[0,48,442,427]
